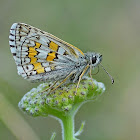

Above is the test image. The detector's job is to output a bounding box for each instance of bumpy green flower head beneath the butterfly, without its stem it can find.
[18,77,105,117]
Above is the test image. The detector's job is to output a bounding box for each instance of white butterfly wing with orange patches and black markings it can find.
[9,23,84,81]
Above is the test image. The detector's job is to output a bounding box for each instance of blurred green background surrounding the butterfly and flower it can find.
[0,0,140,140]
